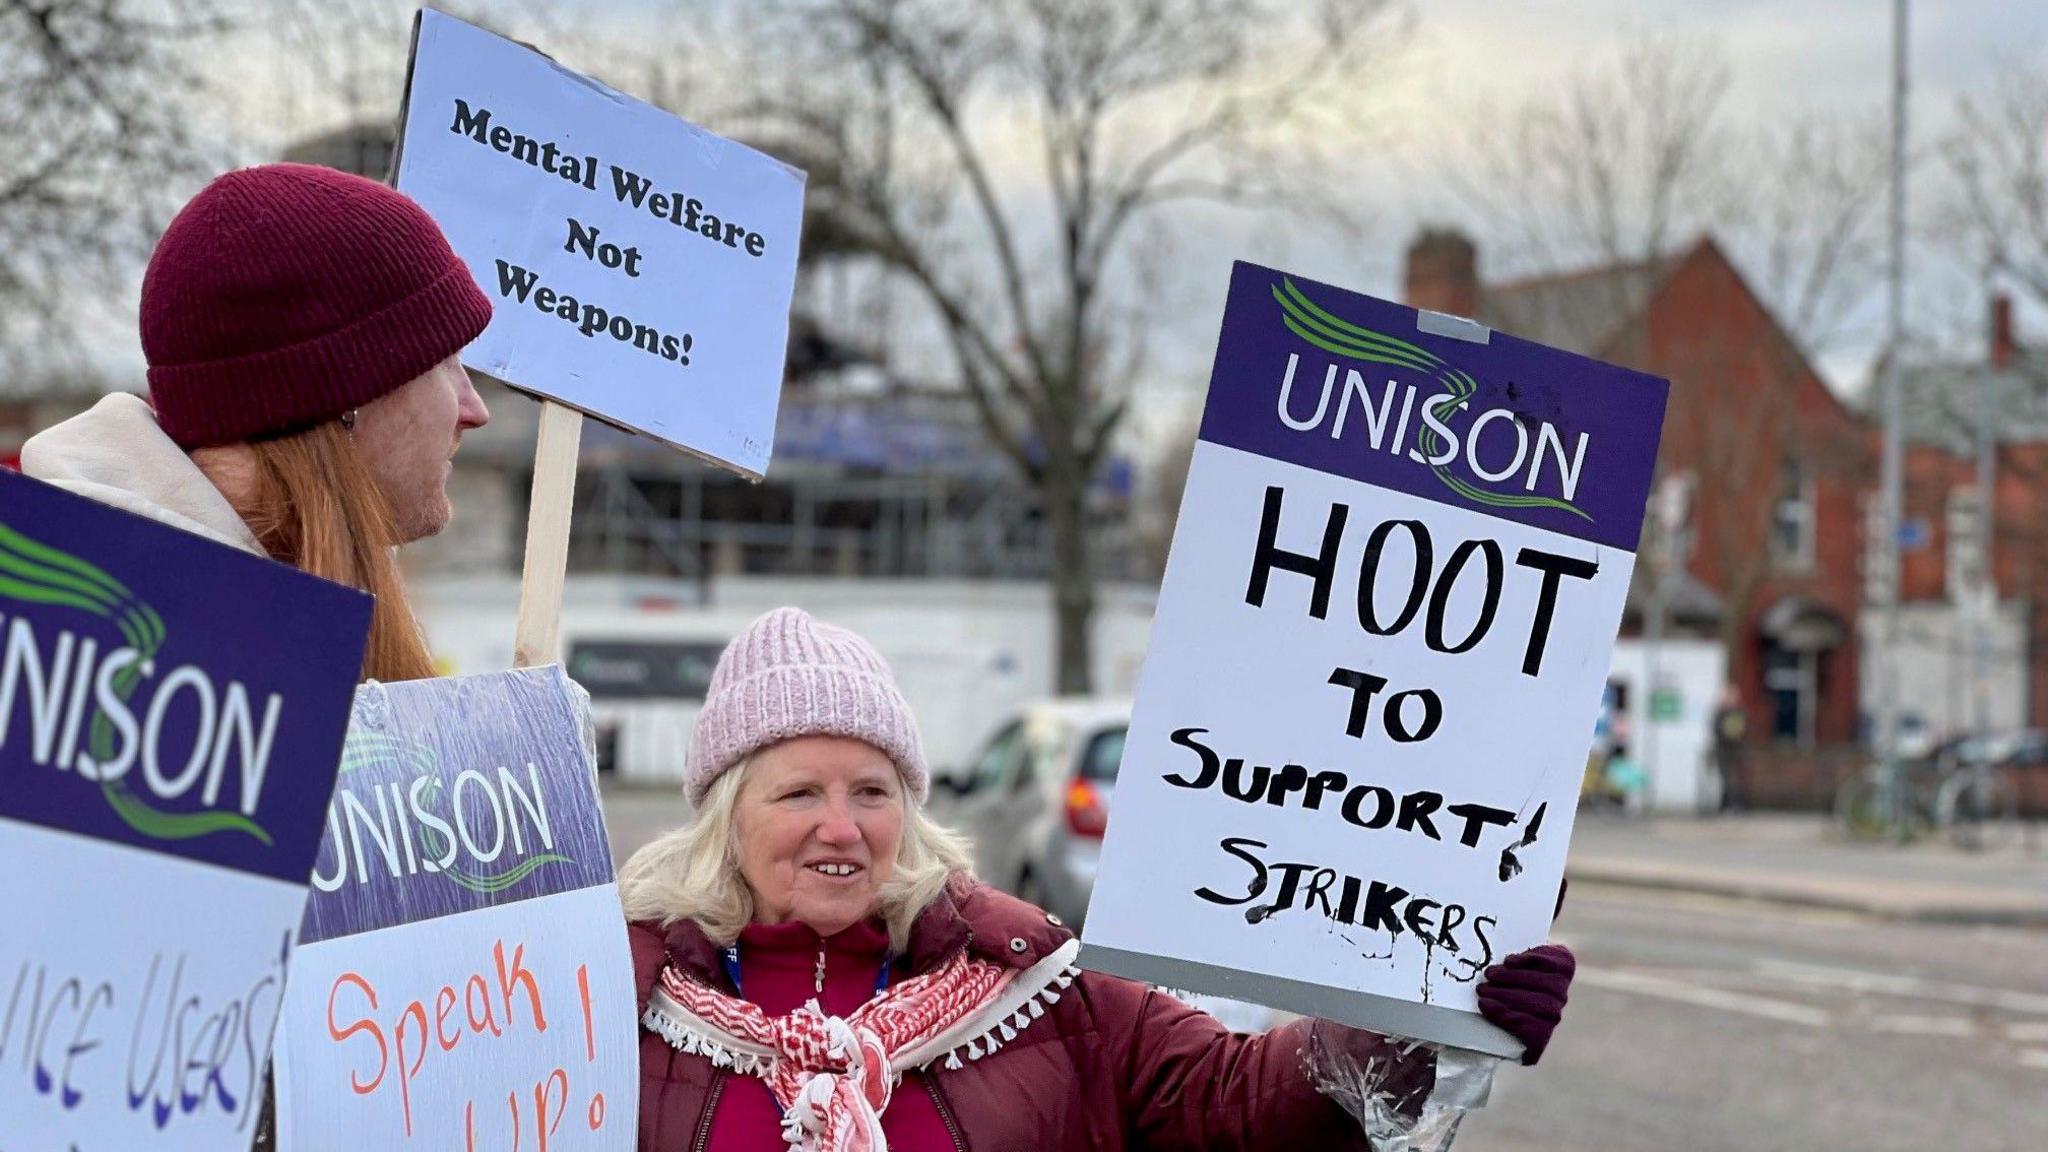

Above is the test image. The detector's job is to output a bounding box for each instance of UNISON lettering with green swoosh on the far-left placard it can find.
[0,523,285,845]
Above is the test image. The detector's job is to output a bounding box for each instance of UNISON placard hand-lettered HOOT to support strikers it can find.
[1081,262,1667,1054]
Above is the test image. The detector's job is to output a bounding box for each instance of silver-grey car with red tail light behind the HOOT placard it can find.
[938,697,1130,927]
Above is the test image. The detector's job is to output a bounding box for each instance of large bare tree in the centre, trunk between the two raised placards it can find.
[720,0,1397,691]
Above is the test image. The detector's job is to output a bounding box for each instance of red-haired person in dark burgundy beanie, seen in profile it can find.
[23,164,492,681]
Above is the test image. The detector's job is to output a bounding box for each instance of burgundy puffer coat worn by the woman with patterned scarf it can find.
[629,881,1434,1152]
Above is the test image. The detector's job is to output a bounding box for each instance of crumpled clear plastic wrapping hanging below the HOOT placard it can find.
[1303,1029,1501,1152]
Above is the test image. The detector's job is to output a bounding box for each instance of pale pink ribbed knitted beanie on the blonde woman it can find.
[682,609,932,804]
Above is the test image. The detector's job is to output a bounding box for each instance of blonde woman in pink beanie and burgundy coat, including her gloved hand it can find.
[618,607,1571,1152]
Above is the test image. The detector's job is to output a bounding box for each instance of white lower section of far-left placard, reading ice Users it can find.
[0,820,305,1152]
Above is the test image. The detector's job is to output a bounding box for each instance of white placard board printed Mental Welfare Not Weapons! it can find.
[397,10,805,480]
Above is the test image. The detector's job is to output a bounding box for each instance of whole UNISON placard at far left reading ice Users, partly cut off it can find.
[0,469,371,1152]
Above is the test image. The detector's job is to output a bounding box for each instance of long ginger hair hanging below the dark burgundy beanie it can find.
[236,420,434,681]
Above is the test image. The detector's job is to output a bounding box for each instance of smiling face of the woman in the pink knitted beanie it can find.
[733,736,903,937]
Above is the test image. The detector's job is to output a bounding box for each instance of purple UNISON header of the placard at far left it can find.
[0,469,371,883]
